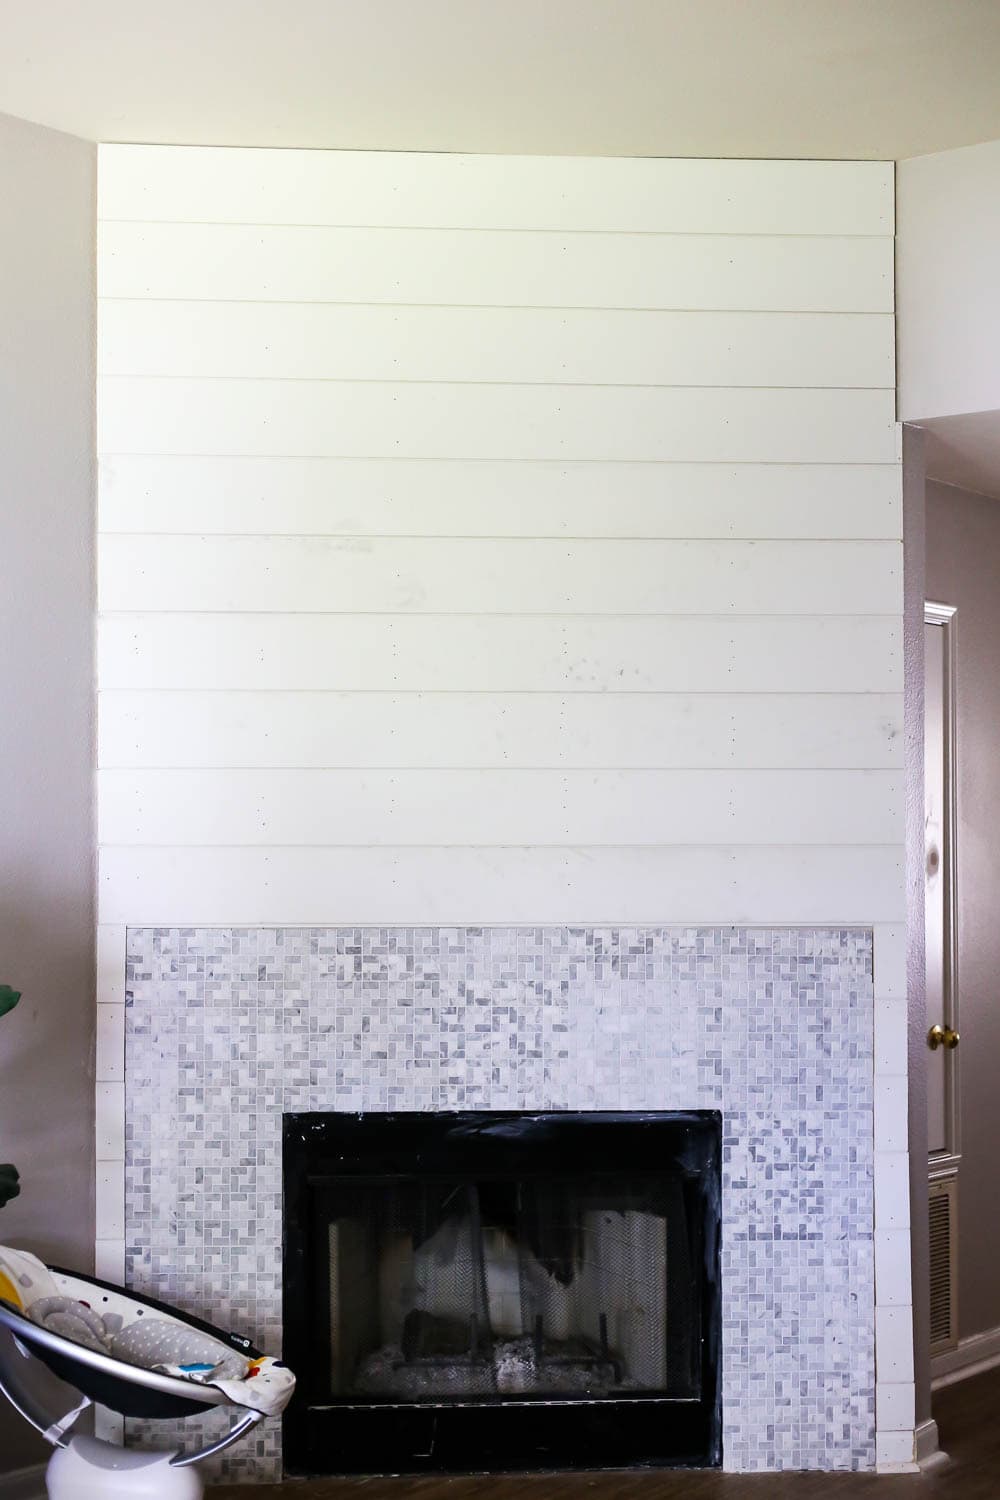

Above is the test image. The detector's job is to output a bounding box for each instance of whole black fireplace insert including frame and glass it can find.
[283,1110,721,1475]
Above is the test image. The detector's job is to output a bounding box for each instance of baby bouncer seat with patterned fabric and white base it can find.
[0,1247,295,1500]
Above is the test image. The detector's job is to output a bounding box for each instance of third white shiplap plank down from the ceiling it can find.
[97,300,895,389]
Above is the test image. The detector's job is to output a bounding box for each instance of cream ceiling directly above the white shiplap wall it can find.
[0,0,1000,159]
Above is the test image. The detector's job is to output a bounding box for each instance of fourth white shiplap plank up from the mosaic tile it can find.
[99,615,903,693]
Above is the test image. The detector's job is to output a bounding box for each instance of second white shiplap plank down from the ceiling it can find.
[97,222,892,312]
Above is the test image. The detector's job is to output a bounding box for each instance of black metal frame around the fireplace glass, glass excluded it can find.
[283,1110,723,1475]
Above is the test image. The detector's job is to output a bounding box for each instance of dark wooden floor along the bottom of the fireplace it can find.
[211,1370,1000,1500]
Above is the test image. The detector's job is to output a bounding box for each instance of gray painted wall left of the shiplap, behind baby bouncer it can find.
[0,116,96,1472]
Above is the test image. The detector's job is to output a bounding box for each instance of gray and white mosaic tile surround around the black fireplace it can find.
[126,927,876,1481]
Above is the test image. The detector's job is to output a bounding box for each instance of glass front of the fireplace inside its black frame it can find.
[325,1175,700,1401]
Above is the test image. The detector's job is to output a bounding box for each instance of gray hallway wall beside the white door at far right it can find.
[927,482,1000,1338]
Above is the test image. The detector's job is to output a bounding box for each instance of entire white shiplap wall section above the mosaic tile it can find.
[99,147,903,924]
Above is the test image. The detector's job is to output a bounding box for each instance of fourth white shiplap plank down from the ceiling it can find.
[97,375,898,464]
